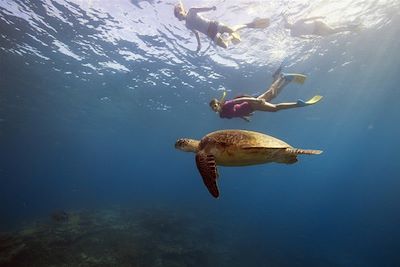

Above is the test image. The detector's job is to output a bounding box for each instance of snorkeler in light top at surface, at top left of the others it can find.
[174,2,269,52]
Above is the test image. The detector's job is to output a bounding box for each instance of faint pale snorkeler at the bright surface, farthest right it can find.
[283,15,359,37]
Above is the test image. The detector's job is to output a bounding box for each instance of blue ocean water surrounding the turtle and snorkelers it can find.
[0,0,400,266]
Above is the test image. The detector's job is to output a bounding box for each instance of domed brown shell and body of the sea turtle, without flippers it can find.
[199,130,295,166]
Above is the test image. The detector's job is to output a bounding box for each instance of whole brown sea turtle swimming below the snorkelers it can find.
[175,130,322,198]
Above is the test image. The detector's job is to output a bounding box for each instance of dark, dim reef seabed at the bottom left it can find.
[0,208,228,267]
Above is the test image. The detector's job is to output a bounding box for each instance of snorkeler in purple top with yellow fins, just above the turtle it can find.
[210,67,322,121]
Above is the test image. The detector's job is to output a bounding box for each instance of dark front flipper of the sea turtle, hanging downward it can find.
[196,151,219,198]
